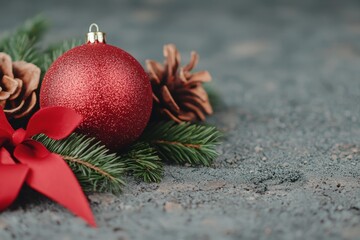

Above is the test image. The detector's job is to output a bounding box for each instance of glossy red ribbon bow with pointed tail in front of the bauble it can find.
[0,107,96,226]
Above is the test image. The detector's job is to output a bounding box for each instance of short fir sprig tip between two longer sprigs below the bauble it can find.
[120,142,164,182]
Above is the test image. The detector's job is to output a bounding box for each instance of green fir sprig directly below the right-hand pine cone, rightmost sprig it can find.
[142,121,222,166]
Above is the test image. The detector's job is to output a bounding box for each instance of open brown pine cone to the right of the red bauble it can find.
[146,44,213,123]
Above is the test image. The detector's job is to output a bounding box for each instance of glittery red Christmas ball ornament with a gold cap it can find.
[40,24,152,150]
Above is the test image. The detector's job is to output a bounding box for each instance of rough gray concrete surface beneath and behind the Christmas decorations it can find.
[0,0,360,240]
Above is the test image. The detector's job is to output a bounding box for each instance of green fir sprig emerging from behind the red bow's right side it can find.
[34,133,125,194]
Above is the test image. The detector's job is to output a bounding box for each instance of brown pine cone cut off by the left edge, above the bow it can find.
[0,52,40,118]
